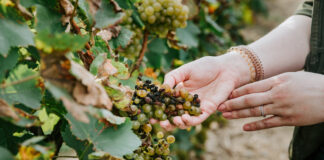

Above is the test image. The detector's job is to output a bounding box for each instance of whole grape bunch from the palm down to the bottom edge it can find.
[124,78,201,160]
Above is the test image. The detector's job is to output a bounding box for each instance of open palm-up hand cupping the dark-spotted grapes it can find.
[160,53,250,130]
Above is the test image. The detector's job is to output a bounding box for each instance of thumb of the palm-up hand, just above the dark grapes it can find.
[164,65,190,87]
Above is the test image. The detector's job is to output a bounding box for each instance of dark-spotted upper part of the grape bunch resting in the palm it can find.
[131,77,201,121]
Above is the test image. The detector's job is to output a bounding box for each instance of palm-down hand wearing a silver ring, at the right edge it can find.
[218,72,324,131]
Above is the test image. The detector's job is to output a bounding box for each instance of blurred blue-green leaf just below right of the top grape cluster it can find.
[177,21,200,48]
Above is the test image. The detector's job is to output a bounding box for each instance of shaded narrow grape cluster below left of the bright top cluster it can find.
[119,10,143,59]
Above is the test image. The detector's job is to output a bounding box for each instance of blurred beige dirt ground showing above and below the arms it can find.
[205,0,301,160]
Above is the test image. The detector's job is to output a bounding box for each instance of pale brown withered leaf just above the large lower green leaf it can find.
[70,61,112,110]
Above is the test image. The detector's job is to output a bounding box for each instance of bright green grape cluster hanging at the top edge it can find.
[136,0,189,37]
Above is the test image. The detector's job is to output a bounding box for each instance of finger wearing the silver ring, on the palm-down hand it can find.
[223,104,278,119]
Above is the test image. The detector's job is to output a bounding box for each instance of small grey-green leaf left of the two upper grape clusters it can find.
[111,27,134,48]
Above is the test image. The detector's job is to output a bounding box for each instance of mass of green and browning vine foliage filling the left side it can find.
[0,0,266,159]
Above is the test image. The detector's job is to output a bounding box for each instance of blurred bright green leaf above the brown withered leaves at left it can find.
[35,32,89,53]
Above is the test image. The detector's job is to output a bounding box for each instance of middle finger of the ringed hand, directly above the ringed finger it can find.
[218,92,272,112]
